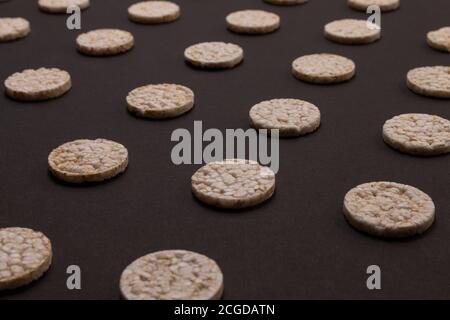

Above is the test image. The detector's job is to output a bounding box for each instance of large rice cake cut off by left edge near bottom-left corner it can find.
[0,228,52,290]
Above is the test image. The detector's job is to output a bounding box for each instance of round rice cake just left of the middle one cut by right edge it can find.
[292,53,356,84]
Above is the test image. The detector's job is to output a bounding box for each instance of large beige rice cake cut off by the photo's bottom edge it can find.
[120,250,223,300]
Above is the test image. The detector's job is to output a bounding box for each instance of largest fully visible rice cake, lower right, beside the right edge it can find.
[344,182,435,238]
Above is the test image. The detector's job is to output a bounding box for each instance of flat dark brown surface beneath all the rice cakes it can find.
[0,0,450,299]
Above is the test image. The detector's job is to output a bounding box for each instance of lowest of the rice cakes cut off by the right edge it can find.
[383,113,450,156]
